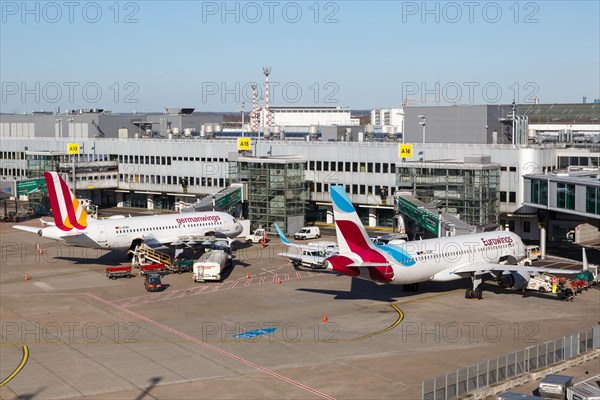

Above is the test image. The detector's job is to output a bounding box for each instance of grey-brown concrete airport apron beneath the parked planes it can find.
[0,221,600,399]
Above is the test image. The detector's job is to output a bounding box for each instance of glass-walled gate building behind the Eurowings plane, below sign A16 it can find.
[397,163,500,225]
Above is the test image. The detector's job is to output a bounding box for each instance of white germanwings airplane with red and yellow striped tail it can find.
[13,172,242,250]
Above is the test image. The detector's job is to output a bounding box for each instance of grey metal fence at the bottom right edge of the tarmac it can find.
[422,326,600,400]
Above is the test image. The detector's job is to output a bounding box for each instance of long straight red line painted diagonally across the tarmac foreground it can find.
[87,293,335,400]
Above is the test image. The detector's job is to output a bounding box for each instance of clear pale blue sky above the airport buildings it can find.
[0,1,600,112]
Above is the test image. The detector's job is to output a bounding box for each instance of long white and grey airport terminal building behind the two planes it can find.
[0,104,600,239]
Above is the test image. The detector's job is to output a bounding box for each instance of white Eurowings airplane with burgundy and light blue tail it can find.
[324,186,585,299]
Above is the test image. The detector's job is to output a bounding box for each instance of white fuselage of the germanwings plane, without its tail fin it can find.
[38,211,242,250]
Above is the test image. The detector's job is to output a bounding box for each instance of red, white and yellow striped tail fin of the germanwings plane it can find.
[44,172,88,231]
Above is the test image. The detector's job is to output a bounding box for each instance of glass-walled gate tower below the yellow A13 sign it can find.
[229,158,308,232]
